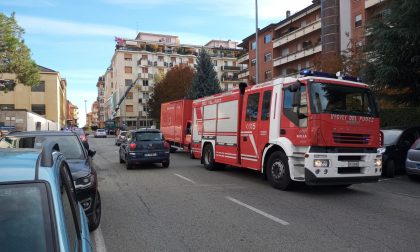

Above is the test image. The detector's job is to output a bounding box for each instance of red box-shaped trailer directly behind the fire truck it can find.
[160,99,192,155]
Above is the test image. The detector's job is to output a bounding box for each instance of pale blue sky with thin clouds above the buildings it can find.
[0,0,312,126]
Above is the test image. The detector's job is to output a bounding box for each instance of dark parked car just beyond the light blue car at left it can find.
[0,131,101,231]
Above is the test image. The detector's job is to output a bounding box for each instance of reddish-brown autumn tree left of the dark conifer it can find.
[147,66,194,121]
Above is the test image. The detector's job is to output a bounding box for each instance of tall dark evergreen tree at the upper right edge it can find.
[364,0,420,105]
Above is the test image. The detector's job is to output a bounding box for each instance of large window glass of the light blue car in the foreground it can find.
[0,183,54,251]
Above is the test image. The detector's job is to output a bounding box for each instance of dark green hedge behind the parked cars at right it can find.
[379,108,420,127]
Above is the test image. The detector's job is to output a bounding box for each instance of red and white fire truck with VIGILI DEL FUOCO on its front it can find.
[192,71,383,190]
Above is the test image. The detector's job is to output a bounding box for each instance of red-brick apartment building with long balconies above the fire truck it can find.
[238,0,357,81]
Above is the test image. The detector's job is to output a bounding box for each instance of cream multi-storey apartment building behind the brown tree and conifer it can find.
[99,32,244,128]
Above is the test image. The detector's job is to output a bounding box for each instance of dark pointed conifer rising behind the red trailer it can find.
[188,48,222,99]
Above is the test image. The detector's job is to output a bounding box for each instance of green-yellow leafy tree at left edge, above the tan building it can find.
[0,13,40,89]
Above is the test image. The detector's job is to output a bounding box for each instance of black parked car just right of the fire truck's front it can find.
[378,127,420,178]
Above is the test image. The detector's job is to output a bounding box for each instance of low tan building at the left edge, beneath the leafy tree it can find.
[0,66,67,128]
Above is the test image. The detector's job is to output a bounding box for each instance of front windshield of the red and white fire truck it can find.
[309,82,378,117]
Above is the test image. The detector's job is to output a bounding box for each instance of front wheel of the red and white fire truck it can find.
[267,151,292,190]
